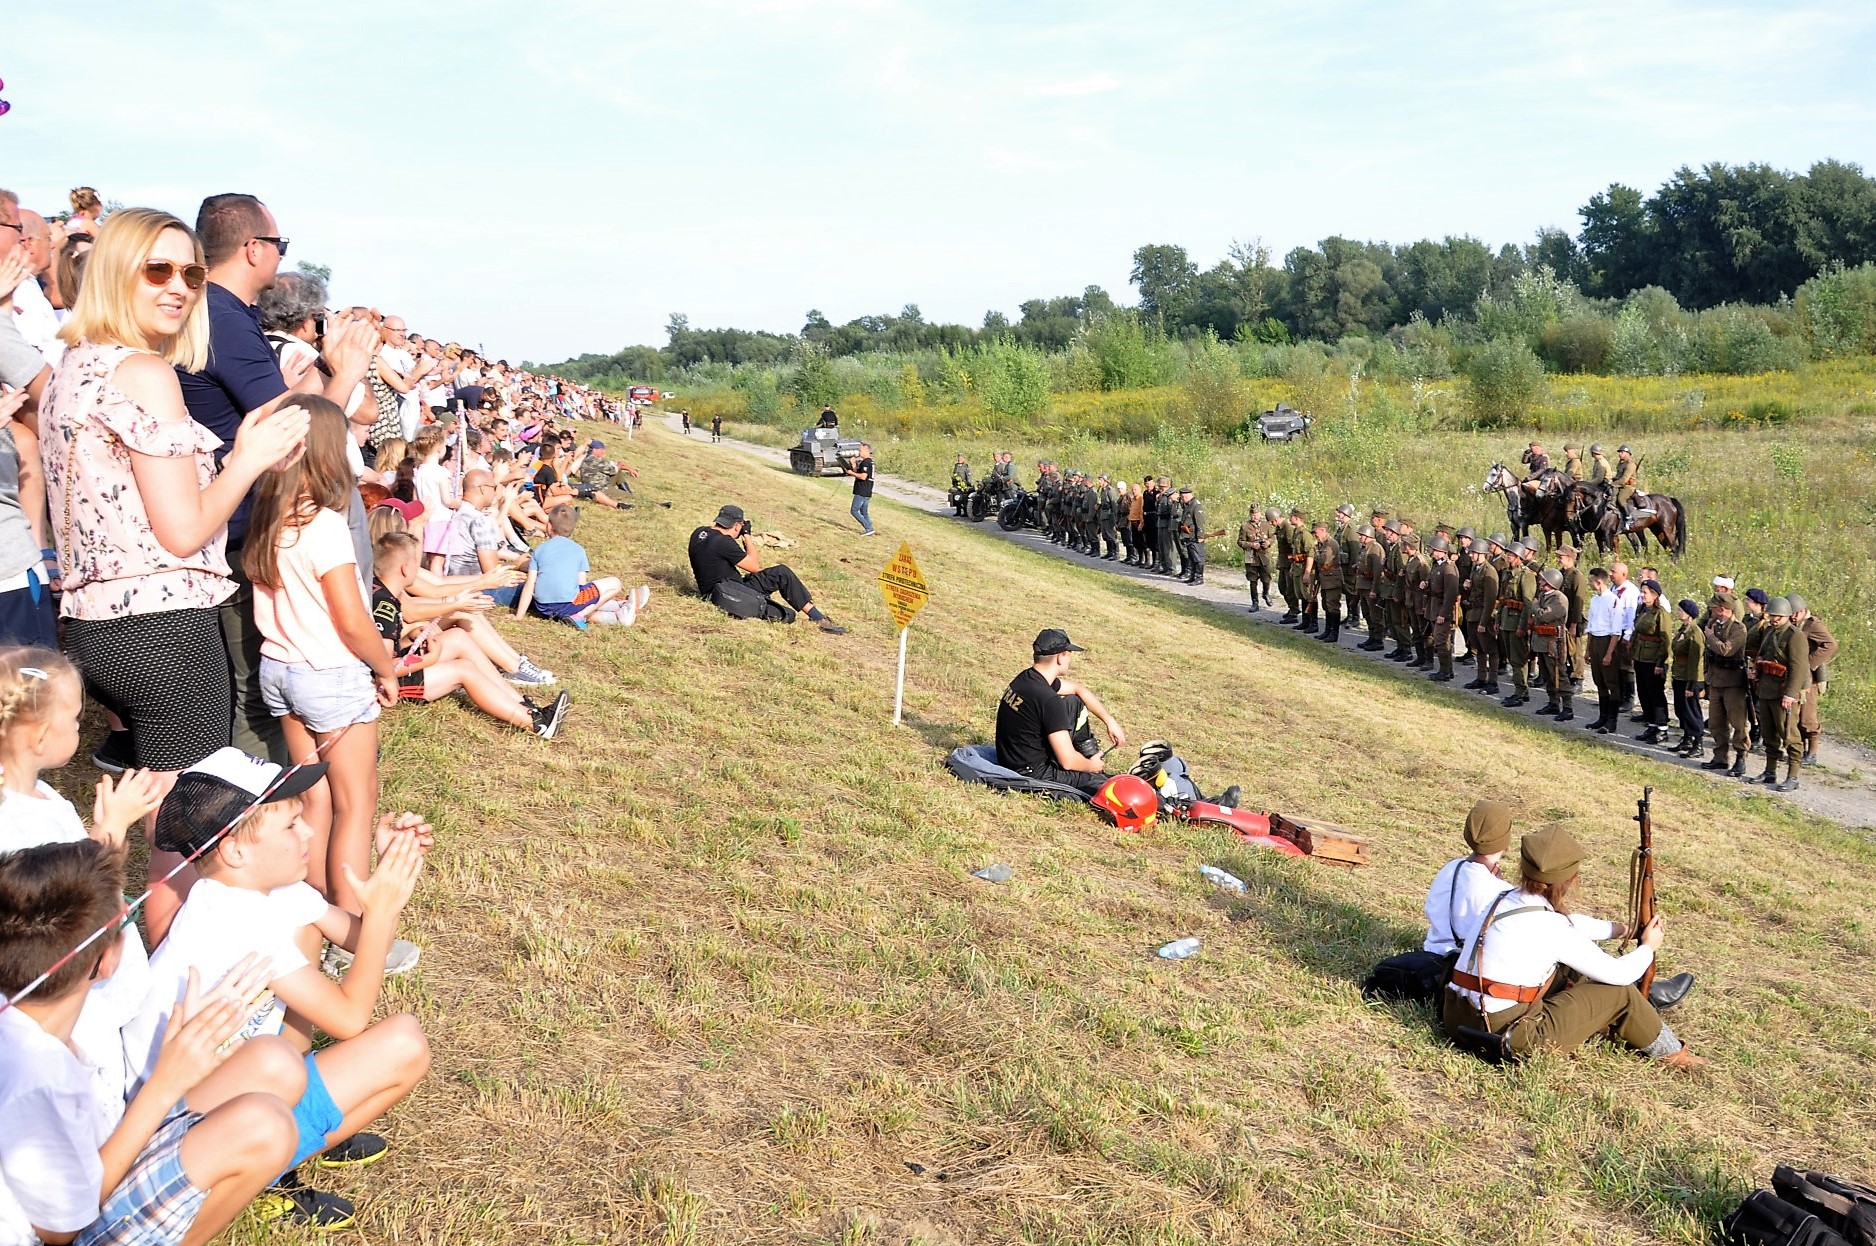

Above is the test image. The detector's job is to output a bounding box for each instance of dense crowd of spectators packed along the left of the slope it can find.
[0,188,649,1246]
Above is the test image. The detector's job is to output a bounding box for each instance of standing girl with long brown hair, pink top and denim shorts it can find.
[242,394,398,912]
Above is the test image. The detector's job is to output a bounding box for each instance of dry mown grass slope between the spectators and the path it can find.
[165,432,1876,1246]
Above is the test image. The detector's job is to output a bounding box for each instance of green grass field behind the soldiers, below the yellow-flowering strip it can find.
[728,413,1876,743]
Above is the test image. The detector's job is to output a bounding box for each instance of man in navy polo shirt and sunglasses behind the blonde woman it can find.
[176,195,377,764]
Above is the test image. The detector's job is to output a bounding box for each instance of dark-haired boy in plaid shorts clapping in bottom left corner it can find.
[0,841,304,1244]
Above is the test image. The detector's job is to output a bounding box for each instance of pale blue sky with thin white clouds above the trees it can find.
[0,0,1876,358]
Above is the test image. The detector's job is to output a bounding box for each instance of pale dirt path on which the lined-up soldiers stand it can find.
[666,417,1876,829]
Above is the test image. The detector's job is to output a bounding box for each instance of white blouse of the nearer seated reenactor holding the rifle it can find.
[1448,888,1655,1013]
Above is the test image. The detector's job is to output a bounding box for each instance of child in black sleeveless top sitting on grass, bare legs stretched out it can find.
[371,533,572,739]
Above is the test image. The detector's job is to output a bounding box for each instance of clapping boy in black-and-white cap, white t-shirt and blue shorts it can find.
[126,749,430,1215]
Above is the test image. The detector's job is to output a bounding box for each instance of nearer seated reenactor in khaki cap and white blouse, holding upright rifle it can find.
[1443,826,1707,1071]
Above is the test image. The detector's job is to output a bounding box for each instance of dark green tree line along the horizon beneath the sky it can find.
[552,160,1876,385]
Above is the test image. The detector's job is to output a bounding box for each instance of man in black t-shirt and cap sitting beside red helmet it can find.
[996,627,1127,796]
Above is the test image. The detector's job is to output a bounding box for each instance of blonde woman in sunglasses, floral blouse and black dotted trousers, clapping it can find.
[39,208,308,942]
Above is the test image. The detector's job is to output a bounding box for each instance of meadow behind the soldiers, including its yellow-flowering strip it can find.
[692,360,1876,743]
